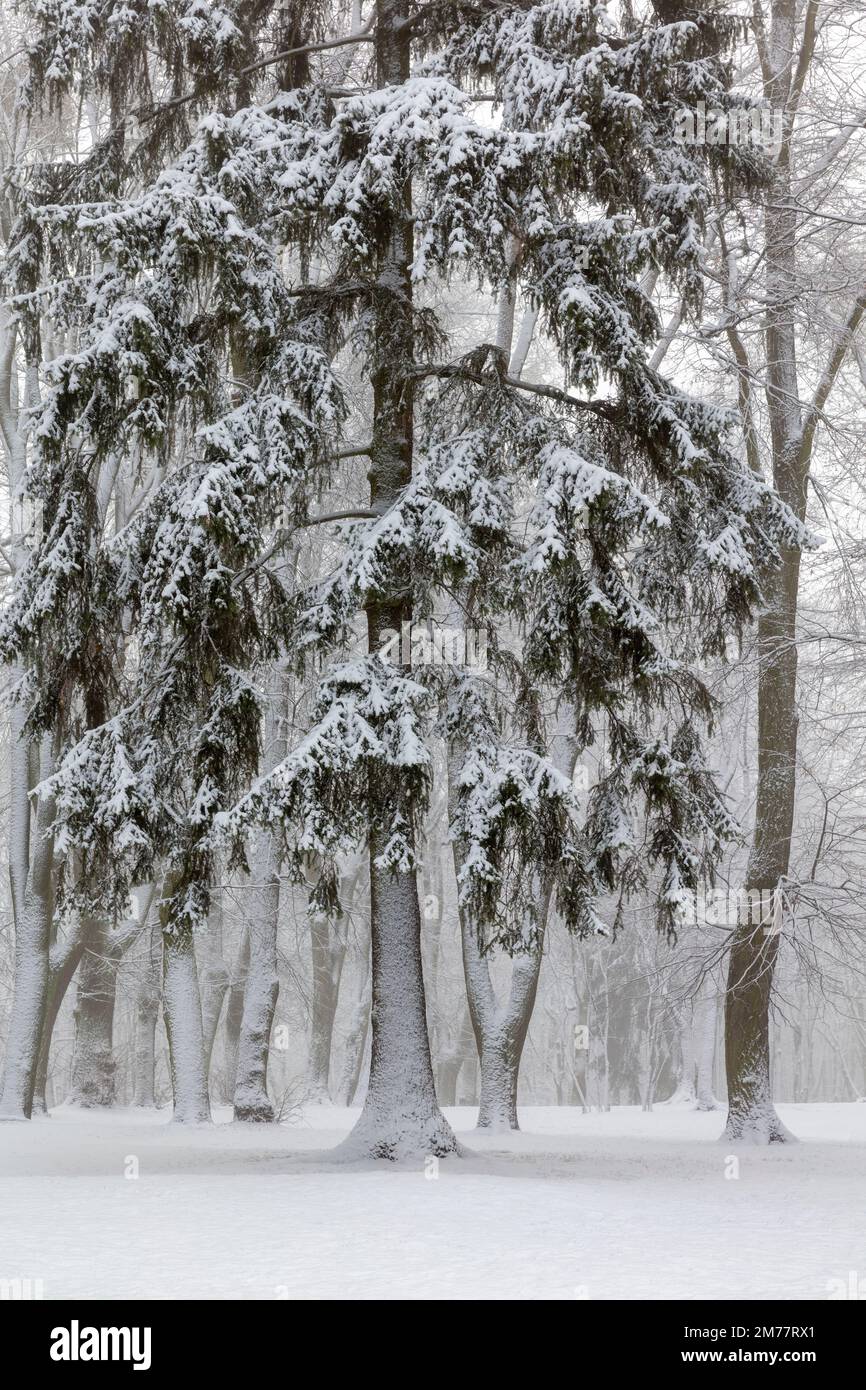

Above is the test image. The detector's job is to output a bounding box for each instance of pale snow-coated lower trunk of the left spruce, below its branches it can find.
[160,874,210,1125]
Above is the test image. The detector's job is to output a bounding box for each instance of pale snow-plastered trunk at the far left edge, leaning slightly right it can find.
[0,737,54,1119]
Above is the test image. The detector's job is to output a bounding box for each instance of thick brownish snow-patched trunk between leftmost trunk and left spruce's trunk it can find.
[70,917,120,1109]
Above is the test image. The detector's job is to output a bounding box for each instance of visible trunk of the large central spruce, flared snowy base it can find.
[343,0,457,1159]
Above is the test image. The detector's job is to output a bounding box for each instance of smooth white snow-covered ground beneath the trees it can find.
[0,1105,866,1300]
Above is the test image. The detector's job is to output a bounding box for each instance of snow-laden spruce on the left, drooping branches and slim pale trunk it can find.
[4,3,346,1119]
